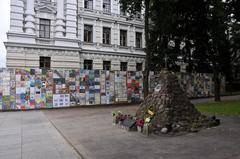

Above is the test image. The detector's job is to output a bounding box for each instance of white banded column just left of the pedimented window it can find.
[25,0,35,34]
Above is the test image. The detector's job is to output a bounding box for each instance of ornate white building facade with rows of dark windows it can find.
[5,0,145,71]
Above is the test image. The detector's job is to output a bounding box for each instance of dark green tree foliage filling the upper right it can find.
[120,0,240,97]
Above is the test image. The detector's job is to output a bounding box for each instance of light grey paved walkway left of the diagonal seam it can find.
[0,111,80,159]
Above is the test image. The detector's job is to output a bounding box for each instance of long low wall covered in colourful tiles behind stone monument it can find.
[0,68,223,110]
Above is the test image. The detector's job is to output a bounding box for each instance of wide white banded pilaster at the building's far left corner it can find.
[10,0,24,33]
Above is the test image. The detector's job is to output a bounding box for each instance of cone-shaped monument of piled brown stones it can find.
[136,71,220,133]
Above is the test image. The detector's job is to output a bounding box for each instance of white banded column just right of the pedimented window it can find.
[56,0,65,37]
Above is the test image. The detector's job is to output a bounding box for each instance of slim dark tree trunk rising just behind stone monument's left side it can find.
[143,0,151,98]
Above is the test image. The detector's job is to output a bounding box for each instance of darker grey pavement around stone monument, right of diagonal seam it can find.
[44,103,240,159]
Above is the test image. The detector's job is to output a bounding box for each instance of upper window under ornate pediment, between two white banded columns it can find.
[39,19,50,38]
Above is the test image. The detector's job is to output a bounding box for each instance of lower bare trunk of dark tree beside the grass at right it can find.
[213,62,221,102]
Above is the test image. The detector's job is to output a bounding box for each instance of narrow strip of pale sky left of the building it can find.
[0,0,10,68]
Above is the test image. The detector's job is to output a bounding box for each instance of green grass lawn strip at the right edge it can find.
[196,100,240,116]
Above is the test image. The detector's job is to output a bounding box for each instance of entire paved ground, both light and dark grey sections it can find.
[0,96,240,159]
